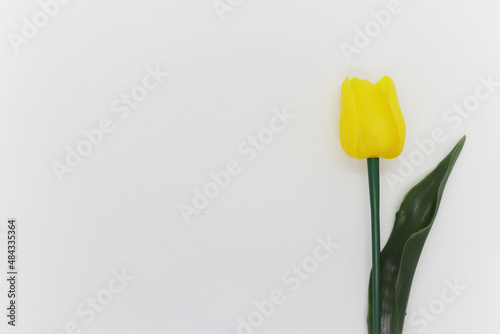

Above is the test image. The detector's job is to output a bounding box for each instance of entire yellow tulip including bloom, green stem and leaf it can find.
[340,76,465,334]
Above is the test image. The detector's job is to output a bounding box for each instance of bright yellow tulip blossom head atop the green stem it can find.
[340,76,406,159]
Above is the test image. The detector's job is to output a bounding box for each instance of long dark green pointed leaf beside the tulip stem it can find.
[367,136,465,334]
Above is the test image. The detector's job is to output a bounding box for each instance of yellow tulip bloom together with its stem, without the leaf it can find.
[340,76,406,334]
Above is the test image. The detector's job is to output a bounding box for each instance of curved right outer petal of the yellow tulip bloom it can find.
[375,76,406,159]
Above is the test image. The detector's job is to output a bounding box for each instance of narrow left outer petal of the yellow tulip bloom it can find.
[340,77,362,159]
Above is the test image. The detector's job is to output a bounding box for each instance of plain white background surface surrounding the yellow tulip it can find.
[0,0,500,334]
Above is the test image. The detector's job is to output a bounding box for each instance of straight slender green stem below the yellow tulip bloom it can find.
[367,158,381,334]
